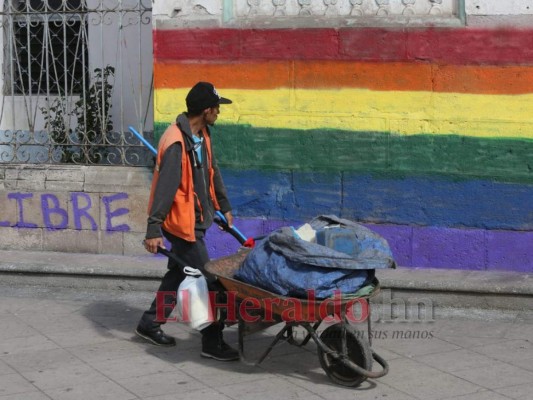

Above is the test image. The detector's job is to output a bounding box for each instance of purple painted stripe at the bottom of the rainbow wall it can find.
[207,219,533,273]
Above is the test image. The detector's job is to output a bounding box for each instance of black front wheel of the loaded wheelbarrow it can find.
[318,323,372,387]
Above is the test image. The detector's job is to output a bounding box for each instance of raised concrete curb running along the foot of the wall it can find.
[0,250,533,310]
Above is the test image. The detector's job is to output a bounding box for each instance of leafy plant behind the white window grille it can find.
[41,65,115,163]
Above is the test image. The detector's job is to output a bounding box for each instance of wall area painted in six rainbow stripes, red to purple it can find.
[154,28,533,272]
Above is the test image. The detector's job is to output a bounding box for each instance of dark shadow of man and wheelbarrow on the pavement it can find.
[76,300,366,390]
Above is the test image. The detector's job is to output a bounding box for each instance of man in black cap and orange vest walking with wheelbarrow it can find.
[135,82,239,361]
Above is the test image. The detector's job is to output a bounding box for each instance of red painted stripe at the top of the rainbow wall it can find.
[154,28,533,65]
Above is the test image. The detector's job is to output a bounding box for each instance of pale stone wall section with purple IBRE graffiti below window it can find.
[0,165,152,255]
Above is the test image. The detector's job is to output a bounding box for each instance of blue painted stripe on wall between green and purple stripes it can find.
[222,169,533,230]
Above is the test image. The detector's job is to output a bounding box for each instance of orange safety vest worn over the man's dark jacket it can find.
[148,123,220,242]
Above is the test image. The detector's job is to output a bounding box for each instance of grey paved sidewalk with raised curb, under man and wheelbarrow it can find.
[0,251,533,400]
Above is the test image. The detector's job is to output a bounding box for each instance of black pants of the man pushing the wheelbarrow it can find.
[139,232,222,330]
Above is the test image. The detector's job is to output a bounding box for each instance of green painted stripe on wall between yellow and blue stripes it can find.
[156,125,533,183]
